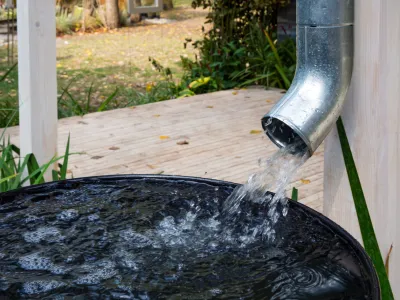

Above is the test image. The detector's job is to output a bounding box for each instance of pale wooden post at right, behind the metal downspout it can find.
[324,0,400,299]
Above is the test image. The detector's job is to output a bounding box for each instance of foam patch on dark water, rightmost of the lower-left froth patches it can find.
[75,260,117,285]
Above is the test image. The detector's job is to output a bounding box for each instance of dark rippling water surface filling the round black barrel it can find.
[0,178,374,299]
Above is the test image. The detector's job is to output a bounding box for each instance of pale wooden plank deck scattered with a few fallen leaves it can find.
[5,88,323,211]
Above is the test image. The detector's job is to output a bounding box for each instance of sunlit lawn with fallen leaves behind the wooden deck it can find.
[0,7,204,128]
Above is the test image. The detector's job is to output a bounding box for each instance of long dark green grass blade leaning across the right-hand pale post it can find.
[337,118,394,300]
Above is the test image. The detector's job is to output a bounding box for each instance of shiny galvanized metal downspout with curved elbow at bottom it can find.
[262,0,354,156]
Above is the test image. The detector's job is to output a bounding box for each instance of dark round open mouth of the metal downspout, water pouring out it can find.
[262,117,308,154]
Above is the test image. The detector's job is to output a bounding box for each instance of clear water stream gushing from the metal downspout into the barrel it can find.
[223,145,308,241]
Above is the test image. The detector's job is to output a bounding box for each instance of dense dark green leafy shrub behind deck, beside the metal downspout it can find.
[177,0,296,92]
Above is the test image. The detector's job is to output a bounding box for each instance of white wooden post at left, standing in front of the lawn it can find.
[17,0,57,180]
